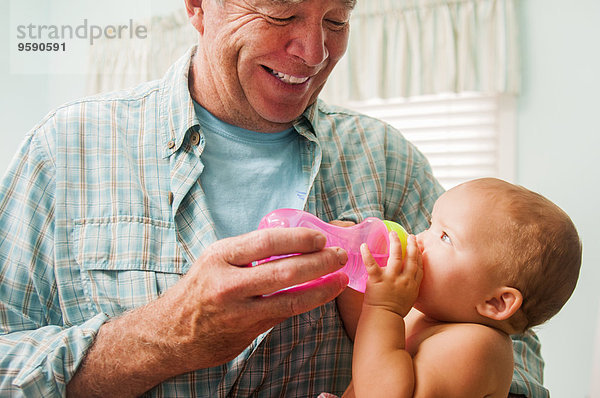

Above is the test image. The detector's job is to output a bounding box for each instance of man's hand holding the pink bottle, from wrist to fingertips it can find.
[164,228,348,370]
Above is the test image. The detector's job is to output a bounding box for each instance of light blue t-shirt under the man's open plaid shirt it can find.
[194,102,309,239]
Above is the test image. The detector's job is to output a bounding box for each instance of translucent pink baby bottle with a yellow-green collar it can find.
[258,209,408,293]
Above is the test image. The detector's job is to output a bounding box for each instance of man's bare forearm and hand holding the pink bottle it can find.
[67,228,348,396]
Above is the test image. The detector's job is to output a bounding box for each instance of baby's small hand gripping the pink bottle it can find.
[360,232,423,317]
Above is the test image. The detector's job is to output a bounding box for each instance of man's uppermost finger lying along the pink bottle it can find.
[215,228,326,266]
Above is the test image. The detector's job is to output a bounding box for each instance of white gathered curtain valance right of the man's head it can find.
[323,0,520,103]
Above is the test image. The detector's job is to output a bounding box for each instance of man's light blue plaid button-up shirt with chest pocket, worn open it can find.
[0,50,542,397]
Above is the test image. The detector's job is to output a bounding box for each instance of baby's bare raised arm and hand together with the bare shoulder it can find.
[354,236,513,398]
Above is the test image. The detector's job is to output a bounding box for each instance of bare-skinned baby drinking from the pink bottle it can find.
[338,178,581,398]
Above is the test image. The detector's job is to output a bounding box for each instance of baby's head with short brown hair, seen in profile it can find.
[415,178,581,333]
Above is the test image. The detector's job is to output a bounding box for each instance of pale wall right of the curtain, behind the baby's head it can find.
[517,0,600,398]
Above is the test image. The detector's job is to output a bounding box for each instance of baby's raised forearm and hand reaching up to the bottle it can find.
[352,233,423,397]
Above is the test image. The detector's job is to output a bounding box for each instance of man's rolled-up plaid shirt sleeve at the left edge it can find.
[0,128,107,397]
